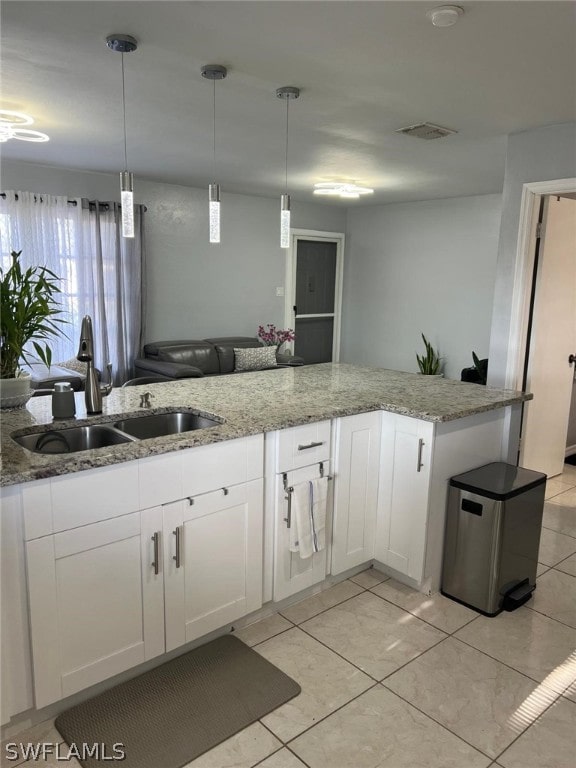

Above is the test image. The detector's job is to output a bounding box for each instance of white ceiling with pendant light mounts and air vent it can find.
[0,0,576,205]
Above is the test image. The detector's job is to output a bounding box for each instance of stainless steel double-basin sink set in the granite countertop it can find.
[11,410,224,454]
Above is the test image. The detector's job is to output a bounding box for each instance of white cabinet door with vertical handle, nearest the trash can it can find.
[375,412,434,583]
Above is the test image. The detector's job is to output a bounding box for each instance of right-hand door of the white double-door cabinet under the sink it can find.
[163,480,263,650]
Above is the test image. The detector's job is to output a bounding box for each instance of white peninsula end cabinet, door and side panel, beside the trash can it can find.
[374,409,505,594]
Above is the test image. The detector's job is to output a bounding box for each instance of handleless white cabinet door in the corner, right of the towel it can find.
[332,411,381,574]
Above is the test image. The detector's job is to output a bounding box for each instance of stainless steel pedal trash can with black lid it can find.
[441,462,546,616]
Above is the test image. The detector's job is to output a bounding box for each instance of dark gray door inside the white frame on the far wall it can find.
[294,239,337,364]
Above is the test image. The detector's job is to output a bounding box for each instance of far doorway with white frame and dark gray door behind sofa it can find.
[285,229,344,365]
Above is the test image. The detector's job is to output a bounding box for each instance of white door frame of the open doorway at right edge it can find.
[505,178,576,389]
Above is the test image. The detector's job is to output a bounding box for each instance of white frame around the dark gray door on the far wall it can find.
[284,229,345,363]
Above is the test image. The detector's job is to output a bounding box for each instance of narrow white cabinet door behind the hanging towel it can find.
[273,461,332,602]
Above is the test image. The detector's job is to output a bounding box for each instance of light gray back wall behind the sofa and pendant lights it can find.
[2,161,346,341]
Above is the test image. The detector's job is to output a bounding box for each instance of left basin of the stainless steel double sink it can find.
[12,424,134,454]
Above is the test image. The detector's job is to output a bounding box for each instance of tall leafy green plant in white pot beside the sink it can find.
[0,251,65,408]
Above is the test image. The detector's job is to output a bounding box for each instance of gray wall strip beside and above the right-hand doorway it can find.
[488,123,576,387]
